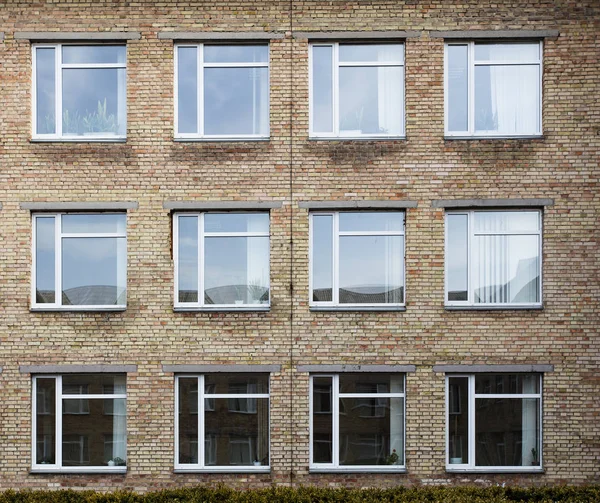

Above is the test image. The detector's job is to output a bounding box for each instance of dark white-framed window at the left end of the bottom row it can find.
[33,374,127,472]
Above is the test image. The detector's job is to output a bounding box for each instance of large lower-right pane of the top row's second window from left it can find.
[204,68,269,135]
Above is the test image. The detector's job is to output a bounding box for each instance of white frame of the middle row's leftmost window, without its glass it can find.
[31,211,127,311]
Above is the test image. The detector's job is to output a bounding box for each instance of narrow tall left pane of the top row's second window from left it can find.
[177,47,198,133]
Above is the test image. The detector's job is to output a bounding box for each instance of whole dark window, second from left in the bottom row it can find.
[175,373,269,471]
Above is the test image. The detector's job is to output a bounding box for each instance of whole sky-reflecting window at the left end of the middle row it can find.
[32,213,127,310]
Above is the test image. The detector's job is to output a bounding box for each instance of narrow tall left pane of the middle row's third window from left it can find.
[312,215,333,302]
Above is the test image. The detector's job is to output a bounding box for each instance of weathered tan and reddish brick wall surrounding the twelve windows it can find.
[0,0,600,490]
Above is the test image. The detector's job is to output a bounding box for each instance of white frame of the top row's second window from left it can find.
[173,41,271,141]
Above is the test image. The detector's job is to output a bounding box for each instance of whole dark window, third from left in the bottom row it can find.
[310,373,404,471]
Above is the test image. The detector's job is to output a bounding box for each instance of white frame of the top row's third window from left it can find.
[308,42,405,139]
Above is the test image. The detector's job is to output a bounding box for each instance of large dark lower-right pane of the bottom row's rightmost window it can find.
[475,398,540,466]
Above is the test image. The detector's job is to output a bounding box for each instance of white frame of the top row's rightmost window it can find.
[444,41,543,138]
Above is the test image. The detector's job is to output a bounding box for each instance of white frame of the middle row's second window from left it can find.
[173,211,271,311]
